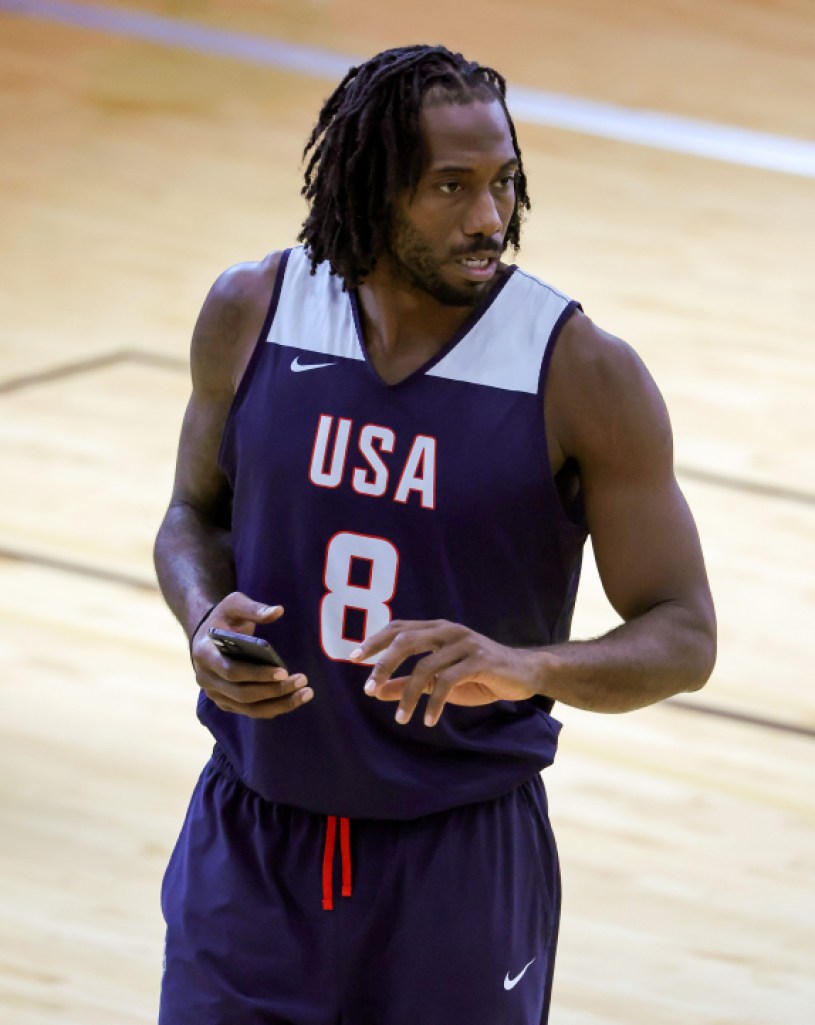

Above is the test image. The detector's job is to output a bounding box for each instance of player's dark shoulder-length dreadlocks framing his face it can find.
[298,46,530,288]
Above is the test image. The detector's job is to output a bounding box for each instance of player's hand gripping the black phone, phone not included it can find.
[190,591,314,719]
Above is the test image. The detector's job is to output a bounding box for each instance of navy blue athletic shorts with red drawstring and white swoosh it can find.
[159,750,560,1025]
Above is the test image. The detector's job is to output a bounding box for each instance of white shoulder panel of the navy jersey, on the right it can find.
[427,269,572,395]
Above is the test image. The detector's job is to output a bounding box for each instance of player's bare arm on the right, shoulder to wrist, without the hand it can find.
[539,314,716,711]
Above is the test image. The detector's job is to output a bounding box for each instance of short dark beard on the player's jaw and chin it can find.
[389,208,503,306]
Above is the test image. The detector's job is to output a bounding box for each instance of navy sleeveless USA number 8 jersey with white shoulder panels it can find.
[209,248,586,819]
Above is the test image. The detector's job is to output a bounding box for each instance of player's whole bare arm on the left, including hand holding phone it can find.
[155,254,314,719]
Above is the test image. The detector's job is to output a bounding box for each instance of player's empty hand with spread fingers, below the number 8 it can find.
[352,619,542,726]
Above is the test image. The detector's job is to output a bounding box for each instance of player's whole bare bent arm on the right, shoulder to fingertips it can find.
[357,314,716,725]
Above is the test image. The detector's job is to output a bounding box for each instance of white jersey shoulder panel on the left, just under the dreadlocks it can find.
[267,246,364,360]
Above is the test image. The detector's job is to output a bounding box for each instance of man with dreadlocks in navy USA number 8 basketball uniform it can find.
[156,46,715,1025]
